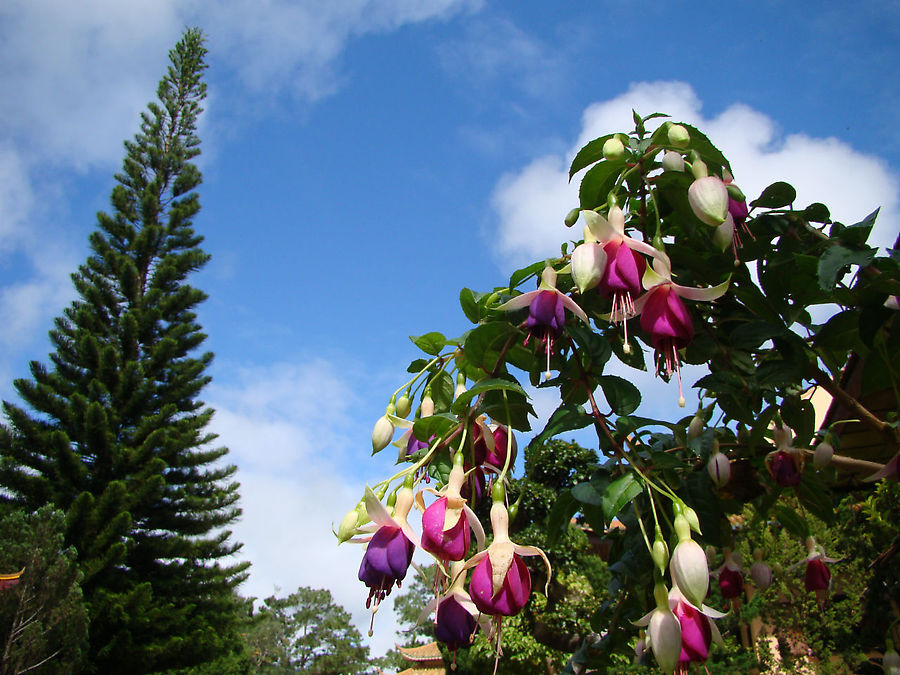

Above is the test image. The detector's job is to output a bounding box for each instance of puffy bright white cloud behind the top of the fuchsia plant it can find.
[492,82,900,267]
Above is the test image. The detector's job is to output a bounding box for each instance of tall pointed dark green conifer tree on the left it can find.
[0,29,246,673]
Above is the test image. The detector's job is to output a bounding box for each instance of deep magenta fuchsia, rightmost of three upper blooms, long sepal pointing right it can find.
[634,252,729,406]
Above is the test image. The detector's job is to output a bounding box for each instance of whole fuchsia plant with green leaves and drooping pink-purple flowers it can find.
[337,113,900,672]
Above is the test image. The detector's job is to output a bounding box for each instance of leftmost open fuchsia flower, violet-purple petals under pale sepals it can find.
[352,486,419,612]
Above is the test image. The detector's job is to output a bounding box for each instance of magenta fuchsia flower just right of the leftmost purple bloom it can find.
[418,452,484,562]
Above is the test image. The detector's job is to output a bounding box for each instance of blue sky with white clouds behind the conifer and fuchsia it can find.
[0,0,900,650]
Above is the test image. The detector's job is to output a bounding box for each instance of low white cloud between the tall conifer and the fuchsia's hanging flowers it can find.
[208,359,397,654]
